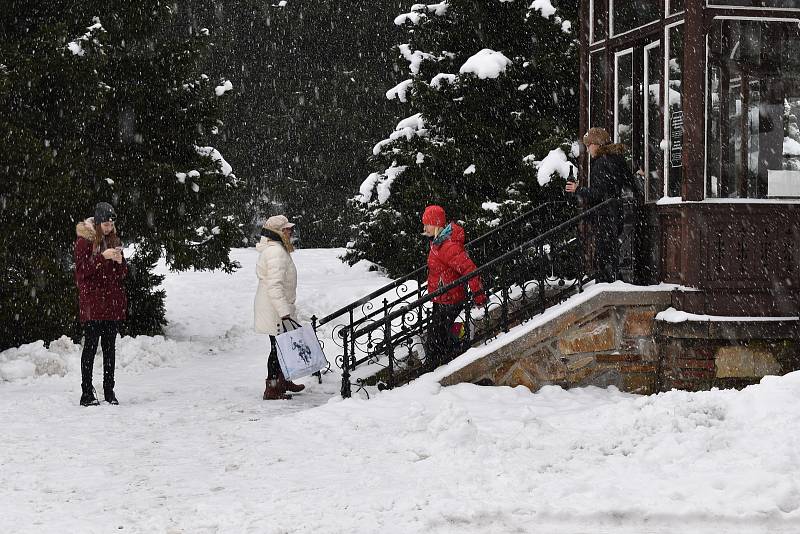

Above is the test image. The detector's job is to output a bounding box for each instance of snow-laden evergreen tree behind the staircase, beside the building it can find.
[347,0,578,276]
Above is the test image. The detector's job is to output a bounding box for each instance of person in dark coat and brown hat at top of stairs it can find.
[565,128,631,282]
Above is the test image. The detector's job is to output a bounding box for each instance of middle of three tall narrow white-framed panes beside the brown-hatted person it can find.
[642,42,664,201]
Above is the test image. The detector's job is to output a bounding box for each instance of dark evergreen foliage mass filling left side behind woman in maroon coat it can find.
[0,0,242,350]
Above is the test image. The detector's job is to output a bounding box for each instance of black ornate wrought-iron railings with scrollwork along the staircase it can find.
[312,200,632,397]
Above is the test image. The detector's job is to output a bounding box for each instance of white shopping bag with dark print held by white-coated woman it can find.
[275,319,328,380]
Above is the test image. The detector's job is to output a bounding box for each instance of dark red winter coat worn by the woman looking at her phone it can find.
[75,222,128,323]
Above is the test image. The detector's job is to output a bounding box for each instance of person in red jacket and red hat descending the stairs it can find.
[422,205,486,370]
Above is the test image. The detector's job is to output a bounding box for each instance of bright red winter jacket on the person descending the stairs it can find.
[428,223,486,304]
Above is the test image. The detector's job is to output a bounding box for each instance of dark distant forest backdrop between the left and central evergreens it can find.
[180,0,410,247]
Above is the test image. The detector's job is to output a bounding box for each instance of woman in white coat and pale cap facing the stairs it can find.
[254,215,305,400]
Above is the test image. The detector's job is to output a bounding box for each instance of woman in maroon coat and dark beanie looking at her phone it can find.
[75,202,128,406]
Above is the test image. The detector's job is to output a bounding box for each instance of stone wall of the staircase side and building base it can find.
[442,292,800,394]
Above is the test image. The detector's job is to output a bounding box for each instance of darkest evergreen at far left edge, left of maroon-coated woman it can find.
[0,2,106,350]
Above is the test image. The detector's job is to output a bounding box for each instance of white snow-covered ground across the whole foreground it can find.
[0,249,800,533]
